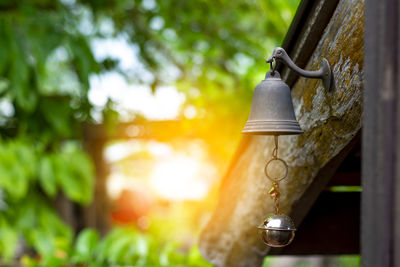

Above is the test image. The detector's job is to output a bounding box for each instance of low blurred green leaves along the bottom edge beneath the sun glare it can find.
[22,227,212,267]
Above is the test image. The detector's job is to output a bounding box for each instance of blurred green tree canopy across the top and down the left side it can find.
[0,0,298,266]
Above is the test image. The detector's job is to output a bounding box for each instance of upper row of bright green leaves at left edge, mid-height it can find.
[0,139,93,204]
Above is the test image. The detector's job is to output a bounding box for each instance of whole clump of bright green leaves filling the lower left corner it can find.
[0,138,93,266]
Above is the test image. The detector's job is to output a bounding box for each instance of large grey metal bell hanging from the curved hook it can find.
[242,70,303,135]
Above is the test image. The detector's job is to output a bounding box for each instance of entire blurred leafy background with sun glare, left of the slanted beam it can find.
[0,0,360,266]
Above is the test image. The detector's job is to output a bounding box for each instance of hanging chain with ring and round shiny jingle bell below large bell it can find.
[258,135,296,247]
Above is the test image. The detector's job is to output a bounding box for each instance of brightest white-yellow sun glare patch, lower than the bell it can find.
[105,140,218,201]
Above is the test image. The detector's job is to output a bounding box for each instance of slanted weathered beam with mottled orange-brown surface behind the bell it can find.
[200,0,364,267]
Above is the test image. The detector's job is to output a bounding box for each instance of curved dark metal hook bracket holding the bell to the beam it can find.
[266,47,332,91]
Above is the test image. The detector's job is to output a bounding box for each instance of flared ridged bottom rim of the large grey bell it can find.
[242,120,303,135]
